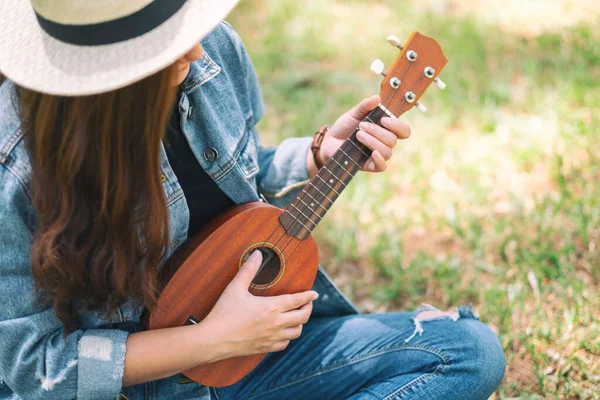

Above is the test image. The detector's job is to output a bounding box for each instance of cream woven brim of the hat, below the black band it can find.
[0,0,239,96]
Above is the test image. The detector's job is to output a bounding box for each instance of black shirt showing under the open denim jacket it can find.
[165,106,235,237]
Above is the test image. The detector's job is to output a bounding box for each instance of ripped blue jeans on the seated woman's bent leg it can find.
[210,305,505,400]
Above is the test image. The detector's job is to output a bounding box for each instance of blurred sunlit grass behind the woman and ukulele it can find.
[229,0,600,399]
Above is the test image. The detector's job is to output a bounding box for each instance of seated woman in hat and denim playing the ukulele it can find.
[0,0,505,399]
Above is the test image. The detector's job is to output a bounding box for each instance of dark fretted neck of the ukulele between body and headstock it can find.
[279,104,392,240]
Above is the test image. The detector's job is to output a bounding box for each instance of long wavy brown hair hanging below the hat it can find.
[18,68,176,331]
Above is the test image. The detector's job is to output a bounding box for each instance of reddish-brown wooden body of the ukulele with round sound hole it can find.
[149,202,319,387]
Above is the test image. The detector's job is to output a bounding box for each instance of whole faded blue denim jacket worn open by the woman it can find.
[0,23,356,399]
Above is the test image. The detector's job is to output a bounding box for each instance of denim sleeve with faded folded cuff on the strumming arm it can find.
[0,164,127,399]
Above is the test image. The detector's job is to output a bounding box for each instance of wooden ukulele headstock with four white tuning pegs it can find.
[371,32,448,117]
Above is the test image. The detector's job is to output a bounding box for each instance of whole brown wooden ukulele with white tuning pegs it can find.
[149,32,448,387]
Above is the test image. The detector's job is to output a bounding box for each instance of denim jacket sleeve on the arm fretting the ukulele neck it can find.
[229,21,312,207]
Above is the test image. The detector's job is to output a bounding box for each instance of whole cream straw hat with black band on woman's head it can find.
[0,0,239,96]
